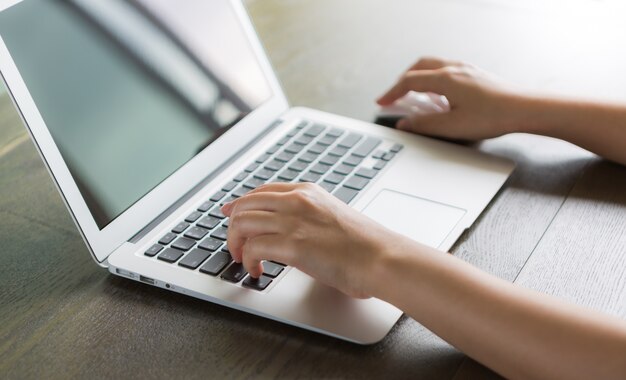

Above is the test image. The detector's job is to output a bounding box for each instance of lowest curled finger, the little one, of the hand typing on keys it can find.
[243,235,295,278]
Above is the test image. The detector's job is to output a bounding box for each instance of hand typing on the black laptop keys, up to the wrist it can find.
[222,183,391,298]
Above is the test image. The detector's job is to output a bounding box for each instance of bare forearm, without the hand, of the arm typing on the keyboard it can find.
[371,241,626,379]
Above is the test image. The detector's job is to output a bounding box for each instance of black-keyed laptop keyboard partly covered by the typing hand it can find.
[144,121,403,291]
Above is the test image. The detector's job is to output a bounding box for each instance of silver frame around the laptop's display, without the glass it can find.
[0,0,289,265]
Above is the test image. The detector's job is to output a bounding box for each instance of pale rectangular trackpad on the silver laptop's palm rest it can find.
[363,189,465,248]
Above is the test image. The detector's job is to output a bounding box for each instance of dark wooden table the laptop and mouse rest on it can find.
[0,0,626,379]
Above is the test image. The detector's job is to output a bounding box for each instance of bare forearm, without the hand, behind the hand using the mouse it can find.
[514,96,626,165]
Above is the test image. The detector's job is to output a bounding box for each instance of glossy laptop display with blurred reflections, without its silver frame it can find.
[0,0,272,229]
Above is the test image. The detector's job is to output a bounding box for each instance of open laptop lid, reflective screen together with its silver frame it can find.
[0,0,288,263]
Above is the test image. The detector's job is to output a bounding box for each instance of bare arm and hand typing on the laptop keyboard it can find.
[223,184,626,379]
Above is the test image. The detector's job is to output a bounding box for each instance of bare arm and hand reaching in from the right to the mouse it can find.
[379,58,626,165]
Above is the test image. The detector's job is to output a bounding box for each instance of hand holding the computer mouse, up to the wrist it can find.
[378,58,523,140]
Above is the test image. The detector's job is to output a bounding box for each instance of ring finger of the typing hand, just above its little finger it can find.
[228,211,281,262]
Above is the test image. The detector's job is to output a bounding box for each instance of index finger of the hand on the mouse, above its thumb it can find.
[378,70,447,106]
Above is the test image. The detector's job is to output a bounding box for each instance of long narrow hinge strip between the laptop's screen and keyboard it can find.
[128,119,283,243]
